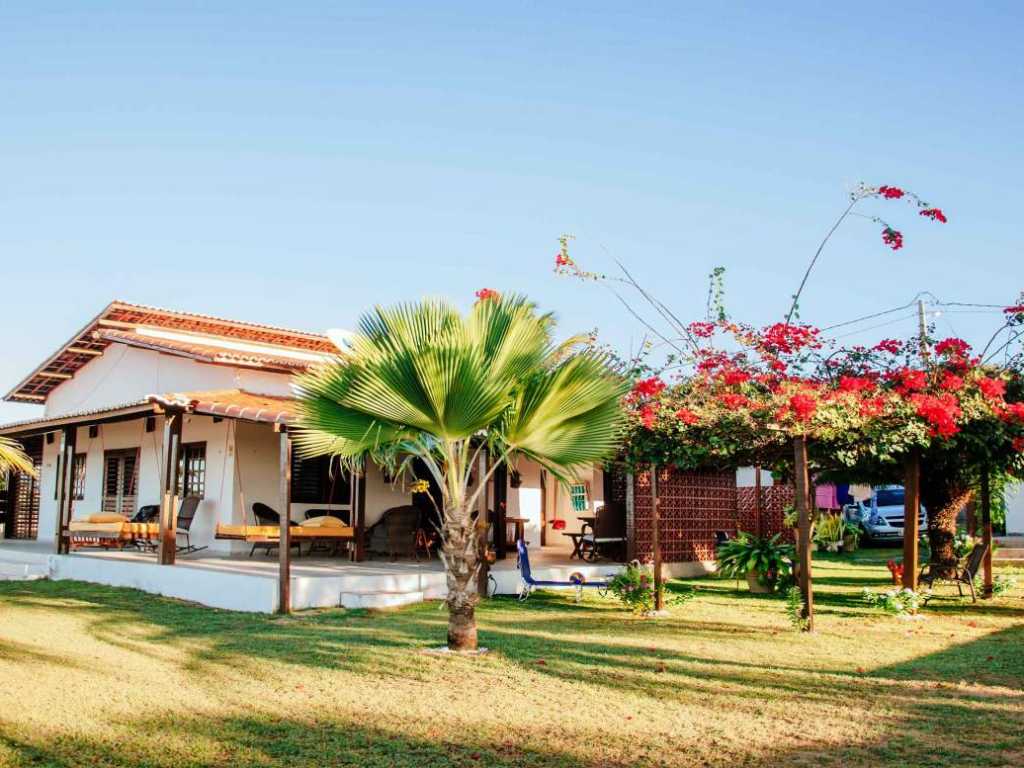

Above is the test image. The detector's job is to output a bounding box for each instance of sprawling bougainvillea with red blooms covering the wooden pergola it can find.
[555,184,1024,570]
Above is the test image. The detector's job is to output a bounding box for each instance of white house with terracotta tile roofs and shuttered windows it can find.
[0,301,604,610]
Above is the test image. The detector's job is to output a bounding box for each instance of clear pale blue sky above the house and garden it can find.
[0,0,1024,421]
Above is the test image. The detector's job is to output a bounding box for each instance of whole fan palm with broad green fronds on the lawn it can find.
[295,292,625,650]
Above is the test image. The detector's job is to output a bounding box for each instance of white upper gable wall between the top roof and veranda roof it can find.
[44,344,291,417]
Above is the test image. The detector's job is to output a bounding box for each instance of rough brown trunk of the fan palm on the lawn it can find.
[441,510,480,651]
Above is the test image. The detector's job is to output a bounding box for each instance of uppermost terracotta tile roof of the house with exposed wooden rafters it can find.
[4,301,337,403]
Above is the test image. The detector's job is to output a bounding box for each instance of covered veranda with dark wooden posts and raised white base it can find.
[2,391,608,611]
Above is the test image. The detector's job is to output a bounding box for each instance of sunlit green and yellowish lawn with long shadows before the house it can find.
[0,550,1024,768]
